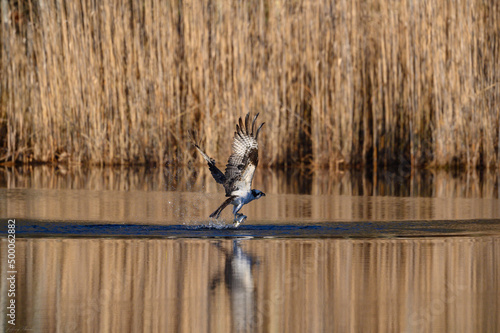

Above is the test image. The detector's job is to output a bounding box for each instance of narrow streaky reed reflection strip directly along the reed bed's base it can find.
[0,165,500,198]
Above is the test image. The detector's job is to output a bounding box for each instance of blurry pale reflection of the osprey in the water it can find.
[210,239,257,331]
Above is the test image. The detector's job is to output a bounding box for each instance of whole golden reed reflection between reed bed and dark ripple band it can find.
[0,166,500,225]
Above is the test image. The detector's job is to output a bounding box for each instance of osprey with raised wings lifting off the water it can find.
[192,113,266,227]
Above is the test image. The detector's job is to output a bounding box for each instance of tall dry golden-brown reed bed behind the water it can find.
[0,0,500,167]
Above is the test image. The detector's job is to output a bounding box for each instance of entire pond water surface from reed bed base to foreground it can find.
[0,166,500,332]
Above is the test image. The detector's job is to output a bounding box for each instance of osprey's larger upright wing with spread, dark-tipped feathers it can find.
[224,113,264,196]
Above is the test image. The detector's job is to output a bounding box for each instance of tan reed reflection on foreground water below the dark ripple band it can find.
[0,236,500,332]
